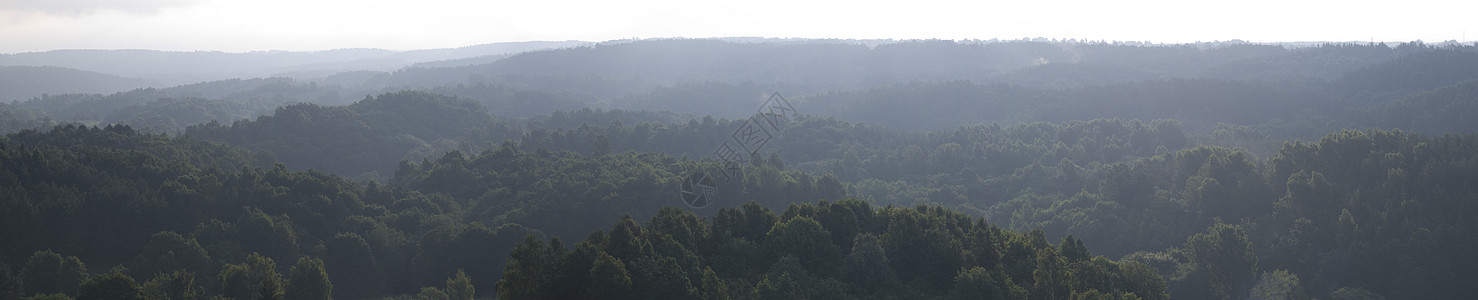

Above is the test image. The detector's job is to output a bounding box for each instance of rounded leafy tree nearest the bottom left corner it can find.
[21,250,87,296]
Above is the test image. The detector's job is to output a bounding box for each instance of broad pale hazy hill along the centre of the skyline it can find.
[392,40,1069,94]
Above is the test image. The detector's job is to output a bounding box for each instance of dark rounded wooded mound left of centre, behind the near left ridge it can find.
[185,92,510,179]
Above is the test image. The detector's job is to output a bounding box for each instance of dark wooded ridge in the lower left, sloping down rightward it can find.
[0,126,534,299]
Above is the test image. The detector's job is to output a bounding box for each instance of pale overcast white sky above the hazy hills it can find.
[0,0,1478,53]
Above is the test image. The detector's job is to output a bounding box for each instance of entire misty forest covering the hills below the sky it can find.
[0,38,1478,300]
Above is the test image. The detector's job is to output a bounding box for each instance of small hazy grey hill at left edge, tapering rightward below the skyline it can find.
[0,67,160,102]
